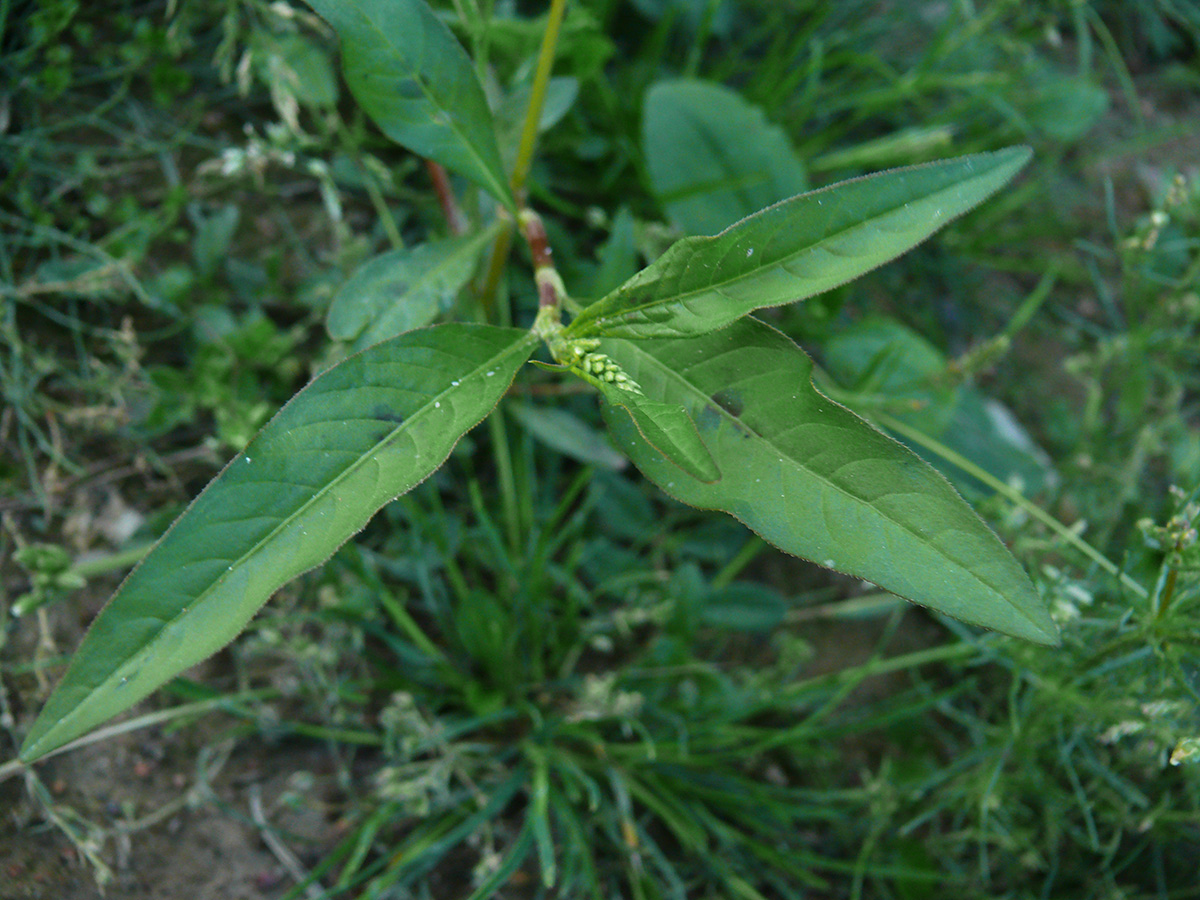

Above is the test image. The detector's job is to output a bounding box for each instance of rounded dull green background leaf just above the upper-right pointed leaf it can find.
[642,78,809,240]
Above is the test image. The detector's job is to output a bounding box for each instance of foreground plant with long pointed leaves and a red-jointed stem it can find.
[20,0,1056,762]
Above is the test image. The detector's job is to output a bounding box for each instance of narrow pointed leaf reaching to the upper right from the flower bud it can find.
[566,148,1030,338]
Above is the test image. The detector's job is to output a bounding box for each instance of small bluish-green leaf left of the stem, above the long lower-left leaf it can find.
[325,228,498,350]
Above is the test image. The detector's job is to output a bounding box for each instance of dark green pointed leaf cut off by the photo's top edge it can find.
[306,0,516,212]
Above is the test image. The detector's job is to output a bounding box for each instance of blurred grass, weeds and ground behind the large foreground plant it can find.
[0,0,1200,900]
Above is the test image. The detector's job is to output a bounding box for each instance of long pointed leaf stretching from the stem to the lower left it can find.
[20,324,536,762]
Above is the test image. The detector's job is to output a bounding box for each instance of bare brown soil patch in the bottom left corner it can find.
[0,724,337,900]
